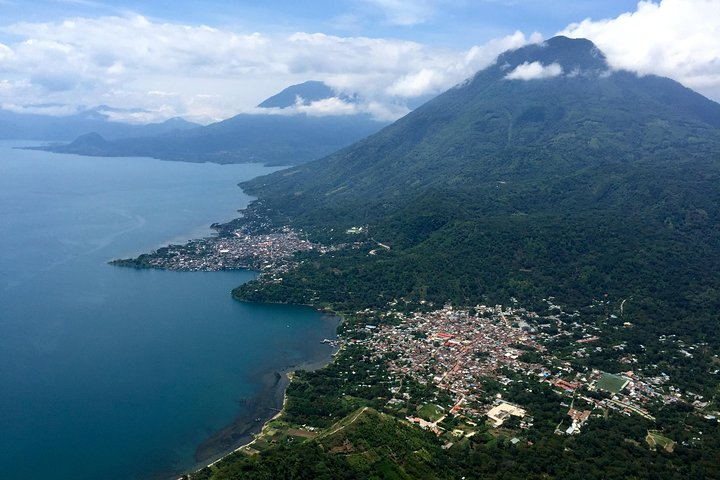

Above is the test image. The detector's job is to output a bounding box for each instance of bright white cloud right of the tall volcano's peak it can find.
[560,0,720,100]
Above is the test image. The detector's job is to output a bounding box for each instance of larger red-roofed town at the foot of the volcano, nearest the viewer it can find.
[316,301,717,452]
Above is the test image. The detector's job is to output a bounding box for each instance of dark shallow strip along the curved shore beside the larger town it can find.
[176,316,344,480]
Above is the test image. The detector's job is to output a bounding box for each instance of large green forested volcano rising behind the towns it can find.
[236,37,720,340]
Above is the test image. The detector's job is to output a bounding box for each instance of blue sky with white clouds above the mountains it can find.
[0,0,720,123]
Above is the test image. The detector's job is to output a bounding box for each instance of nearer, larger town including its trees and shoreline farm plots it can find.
[217,300,717,472]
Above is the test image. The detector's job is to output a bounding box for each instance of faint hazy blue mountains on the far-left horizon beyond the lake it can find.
[0,105,199,141]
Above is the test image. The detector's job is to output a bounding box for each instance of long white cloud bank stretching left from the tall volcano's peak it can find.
[0,15,537,121]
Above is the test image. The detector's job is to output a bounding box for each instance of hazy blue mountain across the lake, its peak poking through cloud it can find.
[28,82,387,165]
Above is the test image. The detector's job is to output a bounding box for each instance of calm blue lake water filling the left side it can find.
[0,142,336,480]
